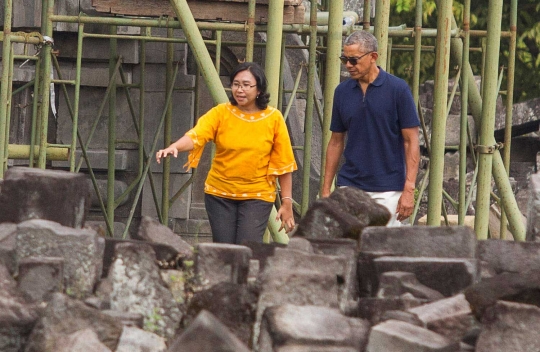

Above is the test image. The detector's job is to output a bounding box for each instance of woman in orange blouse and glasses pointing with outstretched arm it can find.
[156,62,297,244]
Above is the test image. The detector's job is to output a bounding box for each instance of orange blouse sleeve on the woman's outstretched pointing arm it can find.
[184,105,221,170]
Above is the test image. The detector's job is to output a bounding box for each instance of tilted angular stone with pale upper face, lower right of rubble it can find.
[407,294,477,342]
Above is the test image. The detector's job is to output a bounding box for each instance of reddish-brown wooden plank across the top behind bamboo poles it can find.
[92,0,303,24]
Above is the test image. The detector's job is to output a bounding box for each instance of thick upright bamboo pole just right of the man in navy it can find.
[427,0,452,226]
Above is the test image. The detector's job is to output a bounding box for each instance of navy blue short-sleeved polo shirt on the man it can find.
[330,67,420,192]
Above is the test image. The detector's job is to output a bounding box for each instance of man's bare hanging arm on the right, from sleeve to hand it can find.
[396,127,420,221]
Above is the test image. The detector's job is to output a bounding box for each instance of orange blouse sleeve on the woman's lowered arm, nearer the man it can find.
[267,113,297,181]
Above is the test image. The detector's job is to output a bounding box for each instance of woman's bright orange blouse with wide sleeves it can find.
[185,103,297,202]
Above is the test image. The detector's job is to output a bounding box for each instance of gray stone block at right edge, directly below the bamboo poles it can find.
[478,239,540,274]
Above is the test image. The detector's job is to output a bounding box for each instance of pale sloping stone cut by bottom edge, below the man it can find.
[366,320,459,352]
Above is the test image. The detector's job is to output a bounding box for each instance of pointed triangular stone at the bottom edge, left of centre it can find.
[167,310,249,352]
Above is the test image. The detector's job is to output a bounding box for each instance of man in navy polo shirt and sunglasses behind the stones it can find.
[322,31,420,226]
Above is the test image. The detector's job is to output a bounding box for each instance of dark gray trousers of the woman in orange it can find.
[204,193,273,244]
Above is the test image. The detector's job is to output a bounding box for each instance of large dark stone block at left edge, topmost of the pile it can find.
[0,167,90,228]
